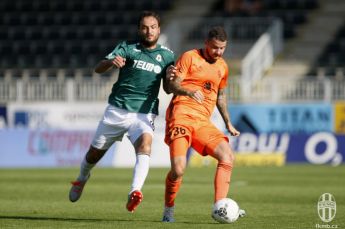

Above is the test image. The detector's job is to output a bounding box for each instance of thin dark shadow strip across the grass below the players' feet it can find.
[0,215,216,225]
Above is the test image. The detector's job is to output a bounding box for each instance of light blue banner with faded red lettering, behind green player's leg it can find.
[0,128,113,167]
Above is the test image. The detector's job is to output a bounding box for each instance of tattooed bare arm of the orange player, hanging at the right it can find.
[216,89,240,136]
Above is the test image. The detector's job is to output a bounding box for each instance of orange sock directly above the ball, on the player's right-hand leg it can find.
[214,162,232,202]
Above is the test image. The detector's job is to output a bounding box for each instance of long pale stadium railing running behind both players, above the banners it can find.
[0,77,345,103]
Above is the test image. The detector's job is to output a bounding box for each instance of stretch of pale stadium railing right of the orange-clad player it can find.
[228,77,345,103]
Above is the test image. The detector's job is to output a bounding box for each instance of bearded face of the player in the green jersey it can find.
[139,16,160,47]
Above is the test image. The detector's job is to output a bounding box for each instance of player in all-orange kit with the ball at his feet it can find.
[162,26,240,222]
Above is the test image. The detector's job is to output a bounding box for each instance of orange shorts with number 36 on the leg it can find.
[165,117,229,157]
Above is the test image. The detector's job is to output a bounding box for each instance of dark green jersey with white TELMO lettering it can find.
[105,41,175,114]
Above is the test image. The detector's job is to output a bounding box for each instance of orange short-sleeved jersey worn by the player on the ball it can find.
[167,49,229,119]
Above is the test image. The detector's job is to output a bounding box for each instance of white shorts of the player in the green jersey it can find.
[91,105,156,150]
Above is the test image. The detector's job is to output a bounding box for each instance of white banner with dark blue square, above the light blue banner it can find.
[7,102,107,130]
